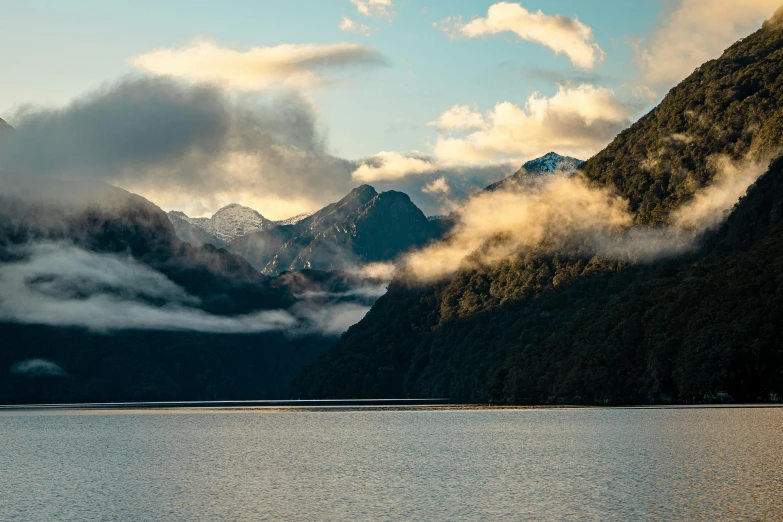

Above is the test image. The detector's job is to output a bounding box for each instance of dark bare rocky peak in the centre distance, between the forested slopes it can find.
[226,185,440,275]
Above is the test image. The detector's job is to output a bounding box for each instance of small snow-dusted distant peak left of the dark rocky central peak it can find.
[168,203,274,246]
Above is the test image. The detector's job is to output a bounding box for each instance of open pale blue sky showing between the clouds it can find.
[0,0,660,158]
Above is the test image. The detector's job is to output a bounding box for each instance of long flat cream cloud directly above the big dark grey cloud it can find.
[131,40,386,91]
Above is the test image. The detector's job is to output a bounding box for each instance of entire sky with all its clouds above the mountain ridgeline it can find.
[0,0,780,219]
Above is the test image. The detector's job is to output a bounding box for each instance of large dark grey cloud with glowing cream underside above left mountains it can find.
[0,77,362,218]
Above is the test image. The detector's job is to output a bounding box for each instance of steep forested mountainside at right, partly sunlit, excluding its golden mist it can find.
[293,10,783,404]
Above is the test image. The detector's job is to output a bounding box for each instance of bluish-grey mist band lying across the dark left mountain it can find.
[0,243,376,334]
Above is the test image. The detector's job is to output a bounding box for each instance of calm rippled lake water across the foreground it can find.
[0,408,783,521]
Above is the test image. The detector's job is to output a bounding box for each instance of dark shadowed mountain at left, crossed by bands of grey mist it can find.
[0,178,385,404]
